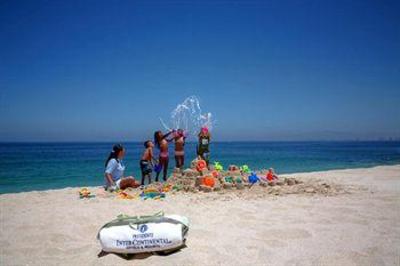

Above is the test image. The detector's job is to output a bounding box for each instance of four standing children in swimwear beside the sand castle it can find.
[140,127,211,186]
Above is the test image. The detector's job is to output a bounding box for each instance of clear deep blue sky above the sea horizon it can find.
[0,0,400,141]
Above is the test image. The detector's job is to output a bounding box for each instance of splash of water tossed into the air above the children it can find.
[160,96,215,135]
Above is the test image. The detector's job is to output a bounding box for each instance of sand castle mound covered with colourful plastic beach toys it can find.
[150,159,345,195]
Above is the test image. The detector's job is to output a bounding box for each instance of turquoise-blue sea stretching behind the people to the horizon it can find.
[0,142,400,193]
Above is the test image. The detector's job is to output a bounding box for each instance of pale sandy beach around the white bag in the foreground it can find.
[0,165,400,265]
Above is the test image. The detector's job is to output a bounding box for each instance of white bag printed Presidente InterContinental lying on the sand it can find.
[97,212,189,254]
